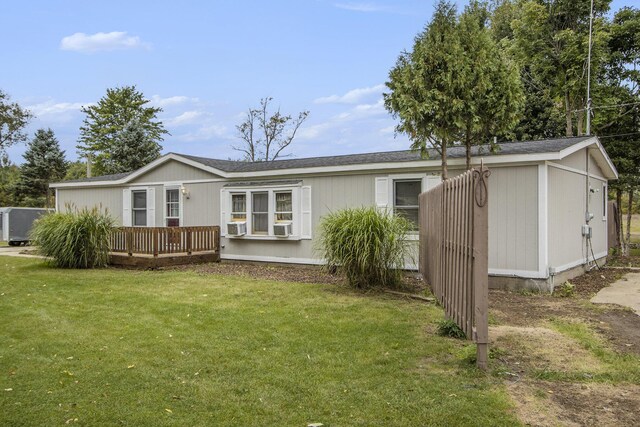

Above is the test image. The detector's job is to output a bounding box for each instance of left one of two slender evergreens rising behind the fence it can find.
[384,1,465,179]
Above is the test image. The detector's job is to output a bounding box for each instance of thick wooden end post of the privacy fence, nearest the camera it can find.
[472,166,490,370]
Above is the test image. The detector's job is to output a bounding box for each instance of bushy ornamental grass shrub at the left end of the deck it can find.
[31,206,115,268]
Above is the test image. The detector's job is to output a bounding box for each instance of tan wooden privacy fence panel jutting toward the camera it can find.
[420,167,490,369]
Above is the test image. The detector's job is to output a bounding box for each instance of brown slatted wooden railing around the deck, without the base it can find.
[111,225,220,256]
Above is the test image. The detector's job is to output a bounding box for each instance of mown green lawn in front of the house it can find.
[0,257,518,426]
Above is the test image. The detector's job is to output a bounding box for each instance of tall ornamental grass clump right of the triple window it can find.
[318,208,411,289]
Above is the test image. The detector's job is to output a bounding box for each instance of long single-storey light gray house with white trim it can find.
[51,137,617,289]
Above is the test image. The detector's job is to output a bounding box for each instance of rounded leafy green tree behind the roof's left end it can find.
[77,86,169,174]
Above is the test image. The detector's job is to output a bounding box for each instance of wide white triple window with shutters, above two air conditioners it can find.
[220,184,312,240]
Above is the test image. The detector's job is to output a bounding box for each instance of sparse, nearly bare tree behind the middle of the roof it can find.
[232,97,309,162]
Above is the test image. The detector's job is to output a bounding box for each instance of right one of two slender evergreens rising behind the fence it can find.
[458,0,524,169]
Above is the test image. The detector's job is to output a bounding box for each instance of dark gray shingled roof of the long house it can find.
[65,136,592,182]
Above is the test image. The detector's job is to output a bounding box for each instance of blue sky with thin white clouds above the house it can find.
[0,0,633,163]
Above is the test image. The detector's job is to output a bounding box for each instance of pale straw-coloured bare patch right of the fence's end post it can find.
[489,326,602,377]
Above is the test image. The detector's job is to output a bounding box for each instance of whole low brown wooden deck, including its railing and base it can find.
[109,226,220,268]
